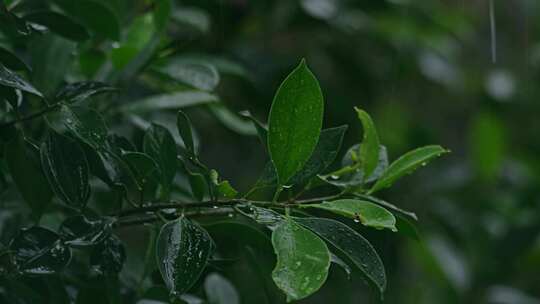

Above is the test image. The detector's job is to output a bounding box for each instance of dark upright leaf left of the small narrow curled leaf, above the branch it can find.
[143,124,177,195]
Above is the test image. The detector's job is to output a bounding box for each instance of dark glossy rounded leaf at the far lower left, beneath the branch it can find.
[9,226,71,275]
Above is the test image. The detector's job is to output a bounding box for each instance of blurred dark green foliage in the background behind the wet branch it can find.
[0,0,540,304]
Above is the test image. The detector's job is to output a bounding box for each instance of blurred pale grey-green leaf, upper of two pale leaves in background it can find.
[159,58,220,91]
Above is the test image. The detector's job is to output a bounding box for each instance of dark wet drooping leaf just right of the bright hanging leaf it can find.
[296,218,386,295]
